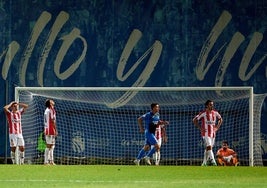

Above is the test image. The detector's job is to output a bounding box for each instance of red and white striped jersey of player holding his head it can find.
[6,108,24,134]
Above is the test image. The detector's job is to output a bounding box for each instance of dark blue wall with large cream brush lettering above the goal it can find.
[0,0,267,159]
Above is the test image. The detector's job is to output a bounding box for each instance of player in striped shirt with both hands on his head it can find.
[4,101,28,164]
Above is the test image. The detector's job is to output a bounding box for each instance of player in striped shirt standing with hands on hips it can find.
[193,100,223,166]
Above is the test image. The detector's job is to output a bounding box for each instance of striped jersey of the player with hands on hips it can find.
[195,110,222,138]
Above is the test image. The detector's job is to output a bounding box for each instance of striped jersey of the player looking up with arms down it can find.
[44,108,56,135]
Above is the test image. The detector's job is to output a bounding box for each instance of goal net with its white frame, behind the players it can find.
[15,87,264,166]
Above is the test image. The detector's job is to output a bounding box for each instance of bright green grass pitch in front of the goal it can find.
[0,165,267,188]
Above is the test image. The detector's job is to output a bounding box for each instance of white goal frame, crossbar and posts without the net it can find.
[15,87,254,166]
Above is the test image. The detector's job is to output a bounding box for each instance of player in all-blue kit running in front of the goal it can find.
[134,103,169,165]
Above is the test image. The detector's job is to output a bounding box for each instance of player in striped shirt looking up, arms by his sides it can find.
[44,99,58,165]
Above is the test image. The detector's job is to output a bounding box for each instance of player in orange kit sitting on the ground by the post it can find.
[216,141,239,166]
